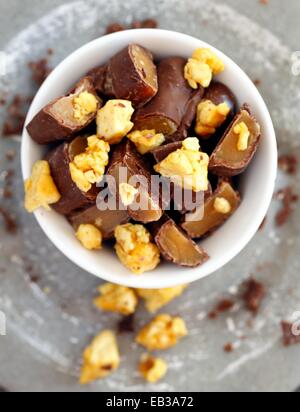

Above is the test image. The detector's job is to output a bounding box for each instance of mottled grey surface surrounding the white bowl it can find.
[0,0,300,392]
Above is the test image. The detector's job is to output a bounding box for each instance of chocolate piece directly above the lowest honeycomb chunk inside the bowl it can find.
[68,205,130,240]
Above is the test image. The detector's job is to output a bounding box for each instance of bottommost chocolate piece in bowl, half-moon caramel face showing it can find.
[151,215,209,268]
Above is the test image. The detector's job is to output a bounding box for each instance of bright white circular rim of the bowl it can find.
[21,29,278,289]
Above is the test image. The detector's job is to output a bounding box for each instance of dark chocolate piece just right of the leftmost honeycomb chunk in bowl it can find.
[47,137,99,215]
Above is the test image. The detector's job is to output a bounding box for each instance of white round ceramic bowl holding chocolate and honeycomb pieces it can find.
[22,30,277,288]
